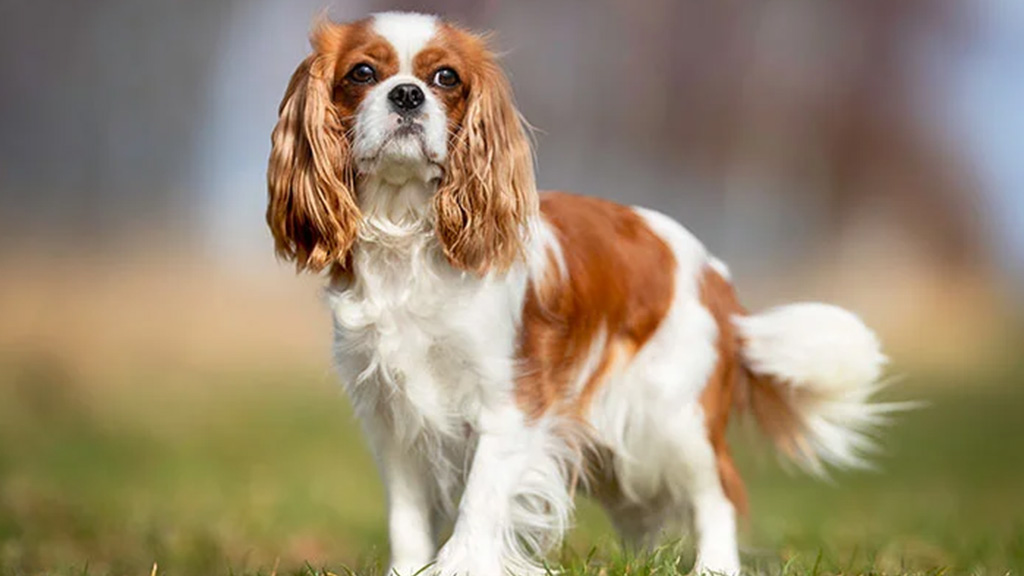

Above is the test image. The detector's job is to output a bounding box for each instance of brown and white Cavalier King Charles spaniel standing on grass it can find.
[267,12,892,576]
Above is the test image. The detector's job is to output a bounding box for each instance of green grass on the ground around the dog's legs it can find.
[0,362,1024,576]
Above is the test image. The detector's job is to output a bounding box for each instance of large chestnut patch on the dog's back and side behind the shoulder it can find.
[516,193,676,418]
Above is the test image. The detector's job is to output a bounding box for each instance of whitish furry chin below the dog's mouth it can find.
[358,128,441,183]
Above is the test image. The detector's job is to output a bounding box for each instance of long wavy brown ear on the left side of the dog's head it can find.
[266,25,360,272]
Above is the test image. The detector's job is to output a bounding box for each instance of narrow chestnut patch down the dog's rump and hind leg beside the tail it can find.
[699,266,749,516]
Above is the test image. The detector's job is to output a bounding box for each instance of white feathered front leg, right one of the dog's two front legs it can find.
[435,408,567,576]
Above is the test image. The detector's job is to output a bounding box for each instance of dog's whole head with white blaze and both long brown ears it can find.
[267,13,537,273]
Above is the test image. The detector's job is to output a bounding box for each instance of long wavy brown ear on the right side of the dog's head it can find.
[434,46,538,275]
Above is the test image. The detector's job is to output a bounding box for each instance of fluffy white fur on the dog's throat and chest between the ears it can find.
[328,175,525,446]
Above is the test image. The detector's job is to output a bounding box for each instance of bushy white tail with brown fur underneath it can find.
[734,303,907,476]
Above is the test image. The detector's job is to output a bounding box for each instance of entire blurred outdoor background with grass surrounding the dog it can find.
[0,0,1024,573]
